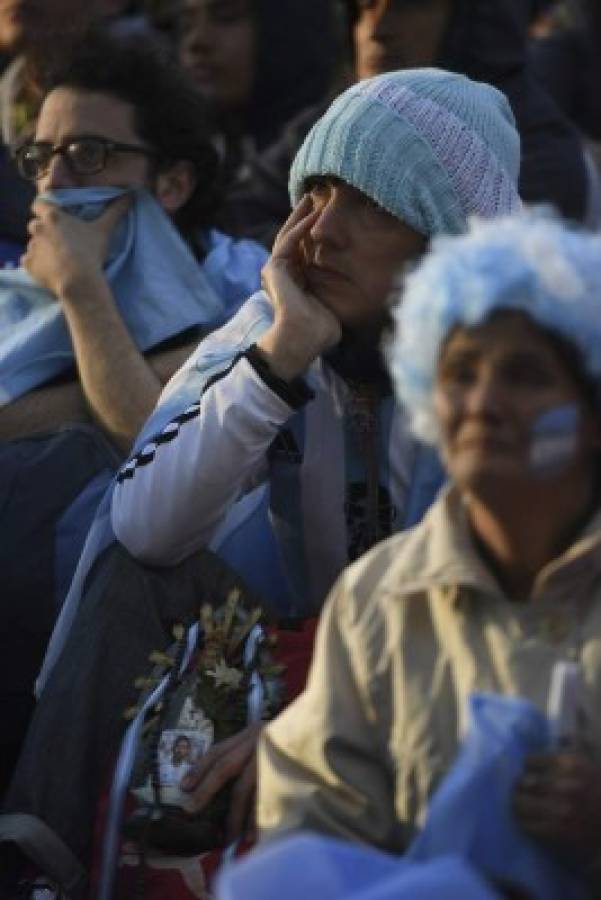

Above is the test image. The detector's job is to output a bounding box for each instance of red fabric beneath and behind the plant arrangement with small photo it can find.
[90,619,317,900]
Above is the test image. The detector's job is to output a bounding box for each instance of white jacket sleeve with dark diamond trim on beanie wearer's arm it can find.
[112,357,294,565]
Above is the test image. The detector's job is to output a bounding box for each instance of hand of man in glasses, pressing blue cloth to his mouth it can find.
[21,196,130,302]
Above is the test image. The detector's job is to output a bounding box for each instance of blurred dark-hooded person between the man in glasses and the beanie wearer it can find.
[179,0,340,245]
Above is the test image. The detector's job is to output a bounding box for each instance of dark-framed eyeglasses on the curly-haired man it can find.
[14,136,156,181]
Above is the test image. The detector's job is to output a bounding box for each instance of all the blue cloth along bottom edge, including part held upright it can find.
[218,692,587,900]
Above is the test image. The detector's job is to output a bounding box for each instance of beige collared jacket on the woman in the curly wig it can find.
[258,489,601,851]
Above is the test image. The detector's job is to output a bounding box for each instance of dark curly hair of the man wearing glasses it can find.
[44,30,221,232]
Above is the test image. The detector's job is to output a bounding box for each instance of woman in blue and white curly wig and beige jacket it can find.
[258,214,601,884]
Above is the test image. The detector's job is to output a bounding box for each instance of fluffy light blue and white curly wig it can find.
[385,209,601,444]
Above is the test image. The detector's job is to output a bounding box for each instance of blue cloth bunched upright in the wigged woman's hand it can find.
[407,694,585,900]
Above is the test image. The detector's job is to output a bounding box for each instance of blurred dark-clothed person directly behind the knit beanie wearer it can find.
[216,0,598,246]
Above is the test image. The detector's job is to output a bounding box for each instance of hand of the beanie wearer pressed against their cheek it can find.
[257,196,342,381]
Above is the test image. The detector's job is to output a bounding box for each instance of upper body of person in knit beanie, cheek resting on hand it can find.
[108,70,520,852]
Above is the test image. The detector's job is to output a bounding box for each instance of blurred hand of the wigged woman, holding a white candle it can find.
[513,750,601,862]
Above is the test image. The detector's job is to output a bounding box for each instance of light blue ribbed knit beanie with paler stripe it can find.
[289,69,521,235]
